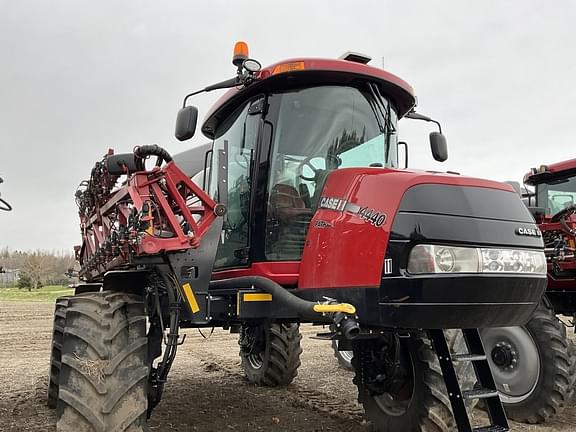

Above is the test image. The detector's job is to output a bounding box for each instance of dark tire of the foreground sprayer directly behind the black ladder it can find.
[353,330,475,432]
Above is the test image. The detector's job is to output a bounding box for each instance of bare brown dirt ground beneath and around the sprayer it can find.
[0,302,576,432]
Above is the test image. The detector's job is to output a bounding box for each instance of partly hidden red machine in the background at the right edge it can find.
[482,159,576,423]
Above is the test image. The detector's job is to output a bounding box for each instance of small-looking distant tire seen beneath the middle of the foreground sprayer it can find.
[239,323,302,387]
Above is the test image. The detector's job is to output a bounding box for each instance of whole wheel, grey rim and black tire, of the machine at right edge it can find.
[481,301,575,424]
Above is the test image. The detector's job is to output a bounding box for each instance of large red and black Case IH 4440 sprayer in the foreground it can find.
[49,43,546,432]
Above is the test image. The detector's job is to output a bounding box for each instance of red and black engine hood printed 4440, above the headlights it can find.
[299,168,542,288]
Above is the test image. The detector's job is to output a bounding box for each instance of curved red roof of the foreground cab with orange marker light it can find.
[202,58,416,138]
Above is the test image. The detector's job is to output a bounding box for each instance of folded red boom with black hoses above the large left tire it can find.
[75,146,226,281]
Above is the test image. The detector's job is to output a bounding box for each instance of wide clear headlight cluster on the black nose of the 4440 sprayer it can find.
[408,245,546,275]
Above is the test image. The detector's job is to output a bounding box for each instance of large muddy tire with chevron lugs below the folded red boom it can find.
[57,291,149,432]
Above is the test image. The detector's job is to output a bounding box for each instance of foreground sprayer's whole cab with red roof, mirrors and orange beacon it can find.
[176,43,446,270]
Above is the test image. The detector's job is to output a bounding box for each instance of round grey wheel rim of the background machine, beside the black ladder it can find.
[482,326,540,404]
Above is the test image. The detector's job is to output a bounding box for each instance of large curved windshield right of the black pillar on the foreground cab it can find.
[266,84,397,260]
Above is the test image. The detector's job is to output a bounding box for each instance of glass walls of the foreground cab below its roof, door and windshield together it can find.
[209,84,397,267]
